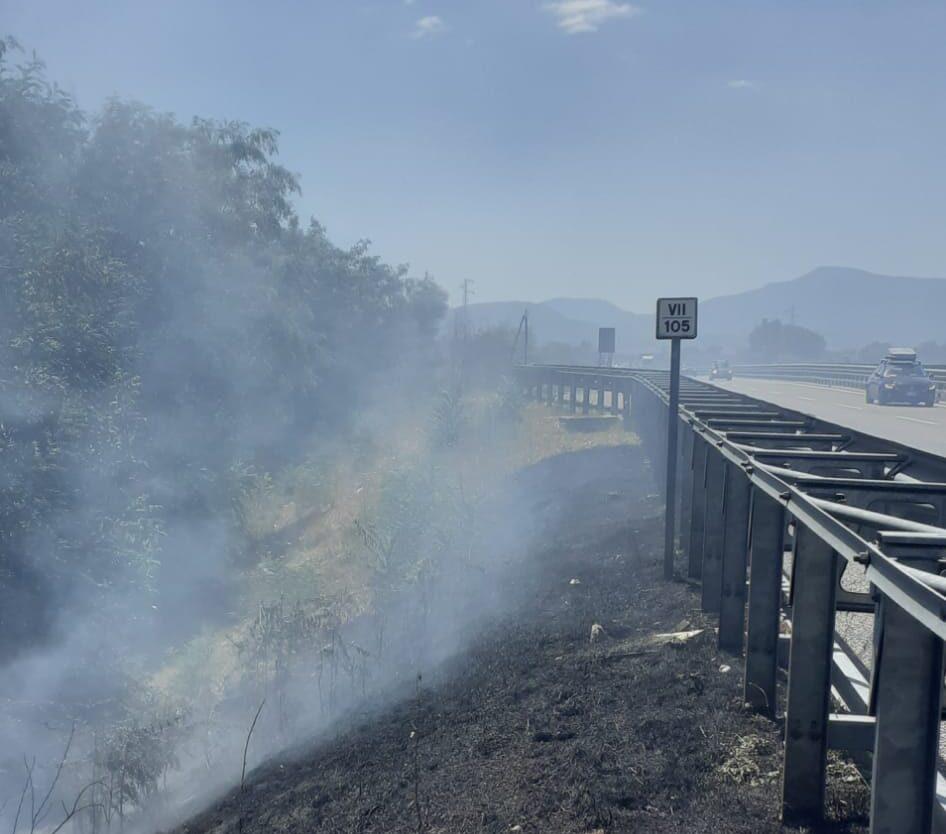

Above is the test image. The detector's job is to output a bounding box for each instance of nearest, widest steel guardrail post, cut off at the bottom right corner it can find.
[870,562,943,834]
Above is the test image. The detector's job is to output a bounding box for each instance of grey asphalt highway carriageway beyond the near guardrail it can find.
[717,378,946,457]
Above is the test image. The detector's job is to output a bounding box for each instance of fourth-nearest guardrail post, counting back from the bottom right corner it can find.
[719,463,750,654]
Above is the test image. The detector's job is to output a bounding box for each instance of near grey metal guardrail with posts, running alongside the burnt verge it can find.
[516,366,946,834]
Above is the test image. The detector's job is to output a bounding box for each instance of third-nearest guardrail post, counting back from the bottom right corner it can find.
[743,488,785,717]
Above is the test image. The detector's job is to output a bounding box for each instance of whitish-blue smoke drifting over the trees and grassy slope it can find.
[0,34,568,834]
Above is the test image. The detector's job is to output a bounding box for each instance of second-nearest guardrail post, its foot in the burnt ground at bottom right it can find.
[782,523,838,823]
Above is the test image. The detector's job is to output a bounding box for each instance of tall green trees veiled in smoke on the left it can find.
[0,38,446,659]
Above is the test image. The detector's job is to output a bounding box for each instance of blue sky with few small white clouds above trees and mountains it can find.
[0,0,946,310]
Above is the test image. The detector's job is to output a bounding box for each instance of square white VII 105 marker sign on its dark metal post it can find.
[657,298,697,579]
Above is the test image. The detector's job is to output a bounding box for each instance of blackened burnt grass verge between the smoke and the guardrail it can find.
[178,447,869,834]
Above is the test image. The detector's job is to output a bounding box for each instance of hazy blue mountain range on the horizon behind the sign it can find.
[448,266,946,353]
